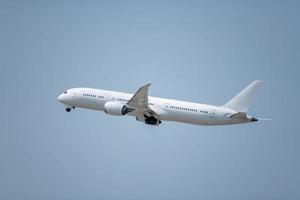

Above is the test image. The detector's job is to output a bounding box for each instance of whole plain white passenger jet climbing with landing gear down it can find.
[57,81,266,126]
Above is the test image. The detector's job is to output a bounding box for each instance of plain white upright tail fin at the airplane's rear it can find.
[223,81,261,112]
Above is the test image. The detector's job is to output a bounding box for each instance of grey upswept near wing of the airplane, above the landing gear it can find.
[127,83,158,118]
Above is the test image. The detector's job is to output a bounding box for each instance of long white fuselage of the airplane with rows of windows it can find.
[57,85,257,125]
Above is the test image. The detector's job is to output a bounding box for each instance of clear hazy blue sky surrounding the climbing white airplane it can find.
[0,1,300,200]
